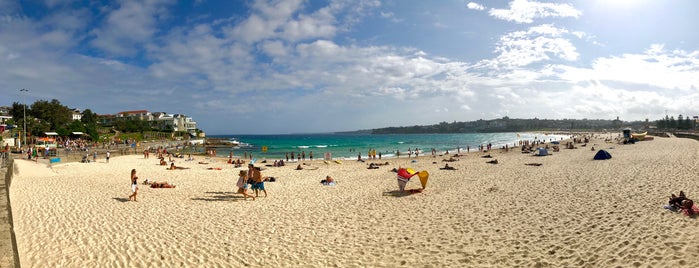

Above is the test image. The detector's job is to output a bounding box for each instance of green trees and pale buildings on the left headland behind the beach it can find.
[0,100,205,150]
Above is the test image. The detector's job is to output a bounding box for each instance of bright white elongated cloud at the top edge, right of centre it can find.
[488,0,582,23]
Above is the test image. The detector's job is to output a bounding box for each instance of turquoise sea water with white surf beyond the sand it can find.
[211,133,568,159]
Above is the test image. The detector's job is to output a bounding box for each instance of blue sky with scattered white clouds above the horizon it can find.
[0,0,699,135]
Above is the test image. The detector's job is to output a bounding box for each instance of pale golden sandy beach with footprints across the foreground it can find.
[10,137,699,267]
